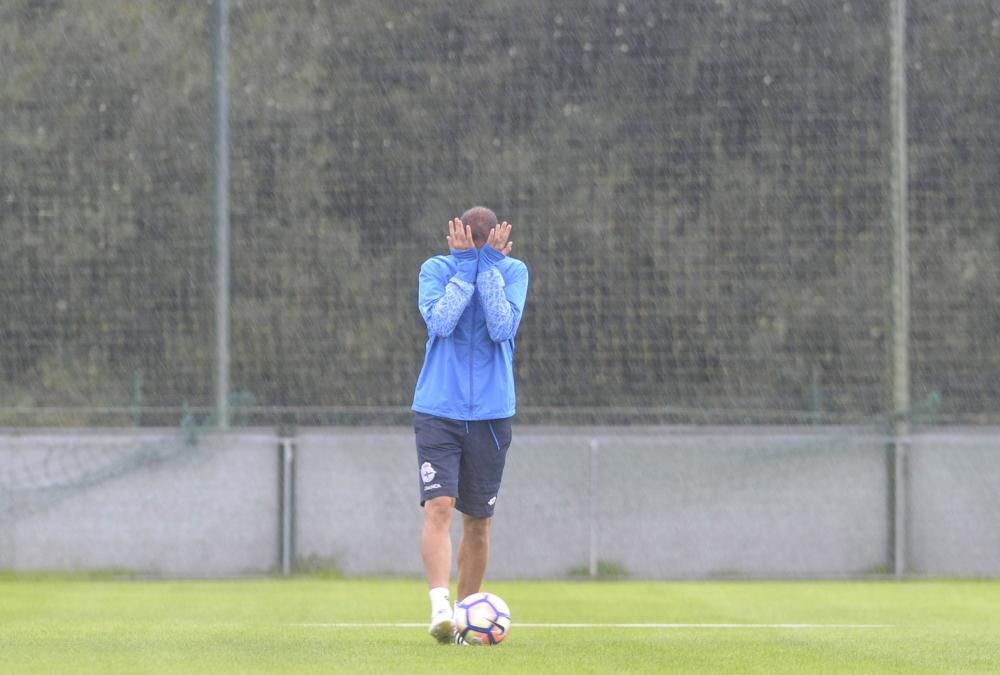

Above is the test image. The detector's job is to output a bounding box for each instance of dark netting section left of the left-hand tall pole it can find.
[0,1,214,425]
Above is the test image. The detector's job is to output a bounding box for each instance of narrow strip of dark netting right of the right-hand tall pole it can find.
[908,0,1000,422]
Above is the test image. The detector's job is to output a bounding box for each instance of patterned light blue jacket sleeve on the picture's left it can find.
[417,249,478,337]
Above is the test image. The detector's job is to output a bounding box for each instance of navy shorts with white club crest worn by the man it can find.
[413,413,511,518]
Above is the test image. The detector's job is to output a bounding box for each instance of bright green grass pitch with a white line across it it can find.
[0,575,1000,675]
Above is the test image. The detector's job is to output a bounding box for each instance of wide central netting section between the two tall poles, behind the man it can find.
[227,1,891,420]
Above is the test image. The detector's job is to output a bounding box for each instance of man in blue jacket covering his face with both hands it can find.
[413,206,528,643]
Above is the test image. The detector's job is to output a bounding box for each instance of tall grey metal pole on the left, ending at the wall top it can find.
[212,0,229,429]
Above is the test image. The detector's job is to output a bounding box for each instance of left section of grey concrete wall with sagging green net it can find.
[0,431,278,576]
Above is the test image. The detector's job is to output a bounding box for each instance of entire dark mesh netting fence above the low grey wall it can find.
[0,0,1000,426]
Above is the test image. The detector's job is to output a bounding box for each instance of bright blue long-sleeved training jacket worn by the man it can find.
[413,244,528,421]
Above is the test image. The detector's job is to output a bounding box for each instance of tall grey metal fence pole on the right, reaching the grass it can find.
[890,0,910,576]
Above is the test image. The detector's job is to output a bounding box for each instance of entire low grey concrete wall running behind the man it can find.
[0,427,1000,578]
